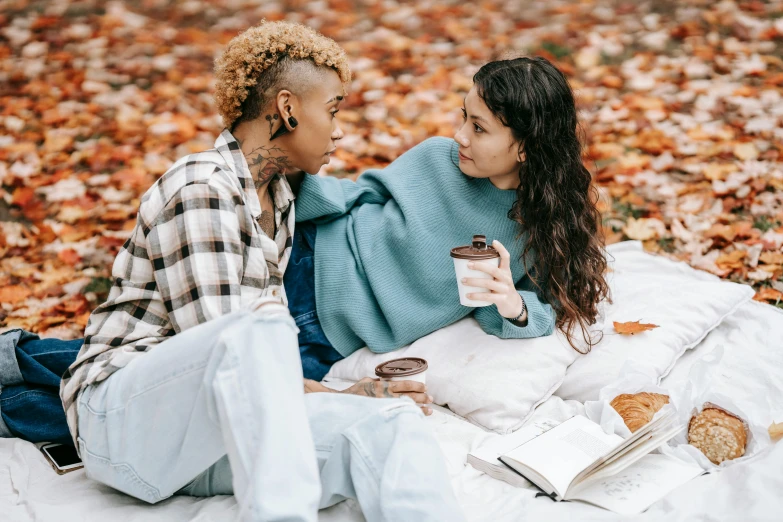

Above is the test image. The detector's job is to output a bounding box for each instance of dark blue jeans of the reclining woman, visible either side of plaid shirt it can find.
[0,219,343,444]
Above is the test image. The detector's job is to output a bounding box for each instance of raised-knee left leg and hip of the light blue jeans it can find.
[77,304,321,522]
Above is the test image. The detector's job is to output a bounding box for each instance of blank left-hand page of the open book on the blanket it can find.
[504,415,623,497]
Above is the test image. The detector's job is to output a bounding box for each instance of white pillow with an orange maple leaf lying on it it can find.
[555,241,754,402]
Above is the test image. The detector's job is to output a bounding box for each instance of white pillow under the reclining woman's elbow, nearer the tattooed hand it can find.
[324,316,578,434]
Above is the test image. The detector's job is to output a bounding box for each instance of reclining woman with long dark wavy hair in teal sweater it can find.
[285,58,608,380]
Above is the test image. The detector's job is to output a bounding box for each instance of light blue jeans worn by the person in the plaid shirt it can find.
[73,304,464,522]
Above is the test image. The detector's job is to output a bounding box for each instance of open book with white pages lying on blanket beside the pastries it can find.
[498,409,703,514]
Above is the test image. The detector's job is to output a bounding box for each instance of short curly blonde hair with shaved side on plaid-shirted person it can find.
[215,20,351,130]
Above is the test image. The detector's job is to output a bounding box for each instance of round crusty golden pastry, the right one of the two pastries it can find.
[688,408,748,464]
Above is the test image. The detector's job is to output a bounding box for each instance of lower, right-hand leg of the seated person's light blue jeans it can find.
[178,393,464,522]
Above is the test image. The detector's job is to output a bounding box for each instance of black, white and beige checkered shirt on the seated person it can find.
[60,130,294,447]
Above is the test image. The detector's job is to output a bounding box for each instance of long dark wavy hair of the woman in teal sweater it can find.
[473,58,609,351]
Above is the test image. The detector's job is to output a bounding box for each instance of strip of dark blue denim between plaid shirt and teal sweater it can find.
[283,222,343,381]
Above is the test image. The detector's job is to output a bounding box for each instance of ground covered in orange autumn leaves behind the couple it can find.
[0,0,783,338]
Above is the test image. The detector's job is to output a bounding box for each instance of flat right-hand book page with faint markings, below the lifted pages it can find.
[568,454,704,515]
